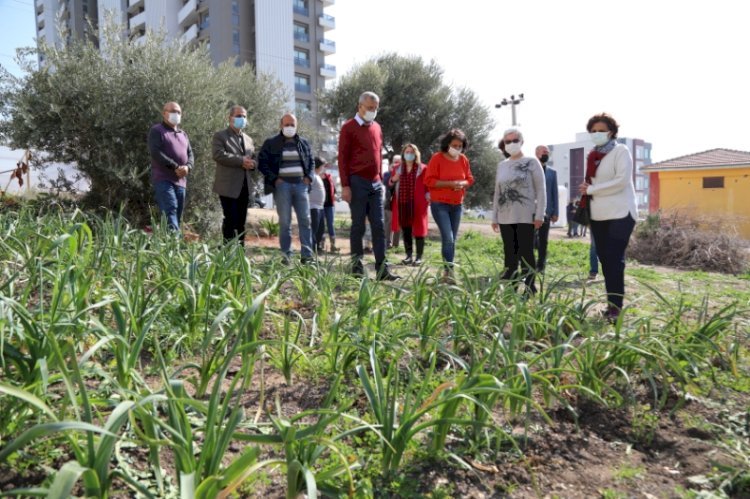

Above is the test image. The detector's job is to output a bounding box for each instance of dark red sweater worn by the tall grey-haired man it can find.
[339,118,383,187]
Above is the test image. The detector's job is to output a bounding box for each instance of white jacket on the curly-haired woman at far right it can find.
[587,144,638,220]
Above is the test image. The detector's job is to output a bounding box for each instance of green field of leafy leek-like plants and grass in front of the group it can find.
[0,201,750,497]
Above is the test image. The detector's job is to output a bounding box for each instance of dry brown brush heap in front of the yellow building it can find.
[628,211,748,274]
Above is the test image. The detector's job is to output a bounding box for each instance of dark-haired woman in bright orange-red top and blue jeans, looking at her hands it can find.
[424,128,474,282]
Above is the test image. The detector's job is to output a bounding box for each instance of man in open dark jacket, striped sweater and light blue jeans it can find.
[258,113,315,263]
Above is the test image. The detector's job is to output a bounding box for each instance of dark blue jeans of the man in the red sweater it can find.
[349,175,385,269]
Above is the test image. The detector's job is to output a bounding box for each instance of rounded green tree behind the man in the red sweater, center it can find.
[321,53,500,207]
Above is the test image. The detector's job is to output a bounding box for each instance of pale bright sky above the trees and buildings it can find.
[0,0,750,161]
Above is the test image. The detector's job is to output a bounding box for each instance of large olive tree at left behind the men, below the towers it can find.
[0,22,285,228]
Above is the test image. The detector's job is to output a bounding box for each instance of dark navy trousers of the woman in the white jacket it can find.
[591,214,635,309]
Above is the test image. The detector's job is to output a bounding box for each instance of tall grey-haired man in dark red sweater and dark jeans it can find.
[339,92,398,281]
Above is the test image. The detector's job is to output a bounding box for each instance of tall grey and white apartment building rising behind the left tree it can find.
[35,0,336,124]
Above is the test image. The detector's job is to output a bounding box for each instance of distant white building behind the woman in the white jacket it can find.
[547,132,651,210]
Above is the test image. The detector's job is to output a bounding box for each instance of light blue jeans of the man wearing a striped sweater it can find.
[273,181,312,258]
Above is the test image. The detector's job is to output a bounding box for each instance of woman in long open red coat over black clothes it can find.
[386,144,430,266]
